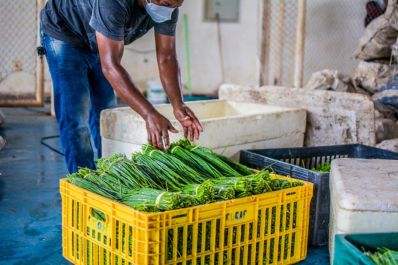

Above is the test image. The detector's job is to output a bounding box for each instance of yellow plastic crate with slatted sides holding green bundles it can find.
[60,175,313,265]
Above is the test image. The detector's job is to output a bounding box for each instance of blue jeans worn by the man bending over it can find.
[41,33,116,173]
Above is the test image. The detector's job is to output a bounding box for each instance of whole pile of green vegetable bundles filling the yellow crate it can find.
[68,140,303,212]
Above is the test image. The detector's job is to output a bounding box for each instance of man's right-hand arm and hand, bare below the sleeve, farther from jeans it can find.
[155,32,203,141]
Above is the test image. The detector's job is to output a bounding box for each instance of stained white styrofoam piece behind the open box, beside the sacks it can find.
[219,84,376,146]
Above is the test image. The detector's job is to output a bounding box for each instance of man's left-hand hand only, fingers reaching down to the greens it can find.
[145,112,178,150]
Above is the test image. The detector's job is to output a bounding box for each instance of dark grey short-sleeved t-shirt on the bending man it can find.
[40,0,178,52]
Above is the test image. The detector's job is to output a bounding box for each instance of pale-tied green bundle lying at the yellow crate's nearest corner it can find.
[122,188,186,212]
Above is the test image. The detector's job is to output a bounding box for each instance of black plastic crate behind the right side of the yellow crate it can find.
[240,144,398,246]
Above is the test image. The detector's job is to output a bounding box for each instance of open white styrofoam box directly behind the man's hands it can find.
[101,100,306,156]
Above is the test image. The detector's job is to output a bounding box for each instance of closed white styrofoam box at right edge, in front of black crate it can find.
[329,158,398,264]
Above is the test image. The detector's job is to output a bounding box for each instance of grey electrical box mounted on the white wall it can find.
[205,0,239,22]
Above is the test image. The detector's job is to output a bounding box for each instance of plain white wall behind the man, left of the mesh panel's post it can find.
[123,0,261,93]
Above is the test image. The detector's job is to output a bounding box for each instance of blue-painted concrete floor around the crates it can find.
[0,109,329,265]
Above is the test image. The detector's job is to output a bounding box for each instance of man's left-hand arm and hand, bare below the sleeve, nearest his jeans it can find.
[96,32,178,149]
